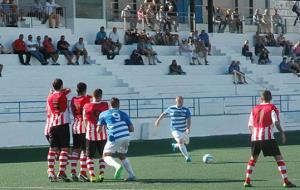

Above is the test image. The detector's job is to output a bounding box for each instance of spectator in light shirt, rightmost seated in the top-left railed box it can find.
[45,0,60,28]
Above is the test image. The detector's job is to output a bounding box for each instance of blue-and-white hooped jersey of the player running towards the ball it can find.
[164,105,191,132]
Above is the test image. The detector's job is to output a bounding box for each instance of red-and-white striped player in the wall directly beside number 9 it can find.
[83,89,108,182]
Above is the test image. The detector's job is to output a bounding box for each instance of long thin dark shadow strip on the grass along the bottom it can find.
[138,179,266,183]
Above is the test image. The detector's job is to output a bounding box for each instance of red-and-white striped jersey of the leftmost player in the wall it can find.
[47,89,71,128]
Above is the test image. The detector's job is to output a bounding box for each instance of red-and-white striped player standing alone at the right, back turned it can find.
[244,90,296,187]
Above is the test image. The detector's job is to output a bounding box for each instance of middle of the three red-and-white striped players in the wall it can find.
[70,82,92,181]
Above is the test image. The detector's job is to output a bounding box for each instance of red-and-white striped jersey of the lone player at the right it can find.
[248,103,279,141]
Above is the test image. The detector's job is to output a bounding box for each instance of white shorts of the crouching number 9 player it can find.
[103,139,129,154]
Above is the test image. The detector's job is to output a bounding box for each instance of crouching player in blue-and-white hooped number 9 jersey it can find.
[98,97,136,181]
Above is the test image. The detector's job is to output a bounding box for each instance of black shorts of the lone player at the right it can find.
[251,139,281,156]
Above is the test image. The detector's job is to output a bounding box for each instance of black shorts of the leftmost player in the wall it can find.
[49,124,70,148]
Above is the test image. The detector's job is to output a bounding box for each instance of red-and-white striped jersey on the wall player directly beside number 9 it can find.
[83,102,108,141]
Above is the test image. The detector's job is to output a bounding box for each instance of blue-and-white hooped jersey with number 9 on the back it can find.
[98,108,132,142]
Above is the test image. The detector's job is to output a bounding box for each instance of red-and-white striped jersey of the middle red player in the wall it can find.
[71,95,92,134]
